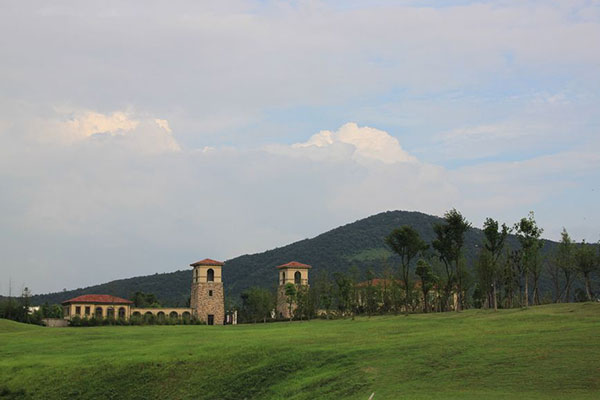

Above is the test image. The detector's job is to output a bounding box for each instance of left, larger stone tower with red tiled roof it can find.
[190,258,225,325]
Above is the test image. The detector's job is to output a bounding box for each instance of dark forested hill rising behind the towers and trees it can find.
[32,211,556,306]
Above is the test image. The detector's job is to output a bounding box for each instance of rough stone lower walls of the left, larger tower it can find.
[190,282,225,325]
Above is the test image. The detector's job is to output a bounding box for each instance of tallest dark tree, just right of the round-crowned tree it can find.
[433,208,471,311]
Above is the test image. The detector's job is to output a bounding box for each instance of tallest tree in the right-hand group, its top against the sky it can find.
[514,211,544,307]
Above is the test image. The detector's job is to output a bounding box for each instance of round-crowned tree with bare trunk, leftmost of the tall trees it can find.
[385,225,429,313]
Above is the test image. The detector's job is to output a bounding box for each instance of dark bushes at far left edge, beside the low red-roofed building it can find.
[0,288,62,325]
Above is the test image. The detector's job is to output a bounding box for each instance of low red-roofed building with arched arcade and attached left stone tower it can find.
[62,258,225,325]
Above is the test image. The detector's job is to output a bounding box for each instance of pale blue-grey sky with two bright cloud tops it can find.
[0,0,600,294]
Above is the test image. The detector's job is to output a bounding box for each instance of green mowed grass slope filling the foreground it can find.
[0,303,600,400]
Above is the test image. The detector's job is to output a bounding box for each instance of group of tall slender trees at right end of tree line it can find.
[474,212,600,308]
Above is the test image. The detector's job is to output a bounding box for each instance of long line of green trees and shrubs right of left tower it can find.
[239,209,600,322]
